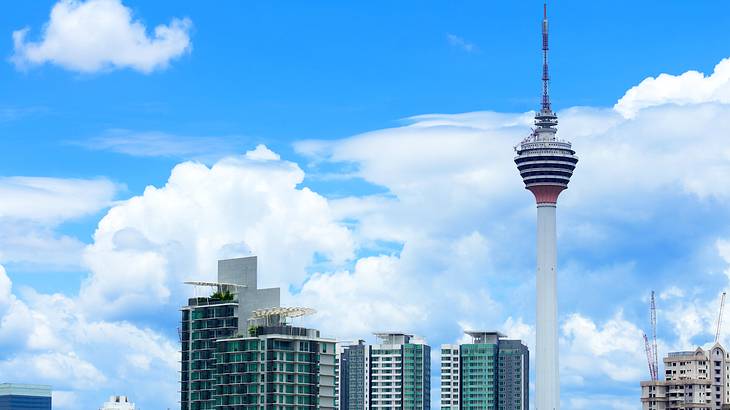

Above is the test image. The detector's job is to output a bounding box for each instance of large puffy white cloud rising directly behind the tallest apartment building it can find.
[81,146,354,313]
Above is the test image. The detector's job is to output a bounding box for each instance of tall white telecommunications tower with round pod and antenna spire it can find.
[515,5,578,410]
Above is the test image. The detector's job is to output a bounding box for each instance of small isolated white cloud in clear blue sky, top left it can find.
[12,0,191,73]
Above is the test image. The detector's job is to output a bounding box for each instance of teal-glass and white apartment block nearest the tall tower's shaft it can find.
[441,332,530,410]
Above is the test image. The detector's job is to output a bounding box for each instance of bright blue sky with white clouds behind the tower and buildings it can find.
[0,0,730,409]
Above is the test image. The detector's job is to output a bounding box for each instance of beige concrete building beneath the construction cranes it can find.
[641,344,730,410]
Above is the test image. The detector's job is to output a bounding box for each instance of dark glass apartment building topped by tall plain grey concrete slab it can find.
[180,256,280,410]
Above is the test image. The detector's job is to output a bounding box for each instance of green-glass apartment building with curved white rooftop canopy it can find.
[213,308,336,410]
